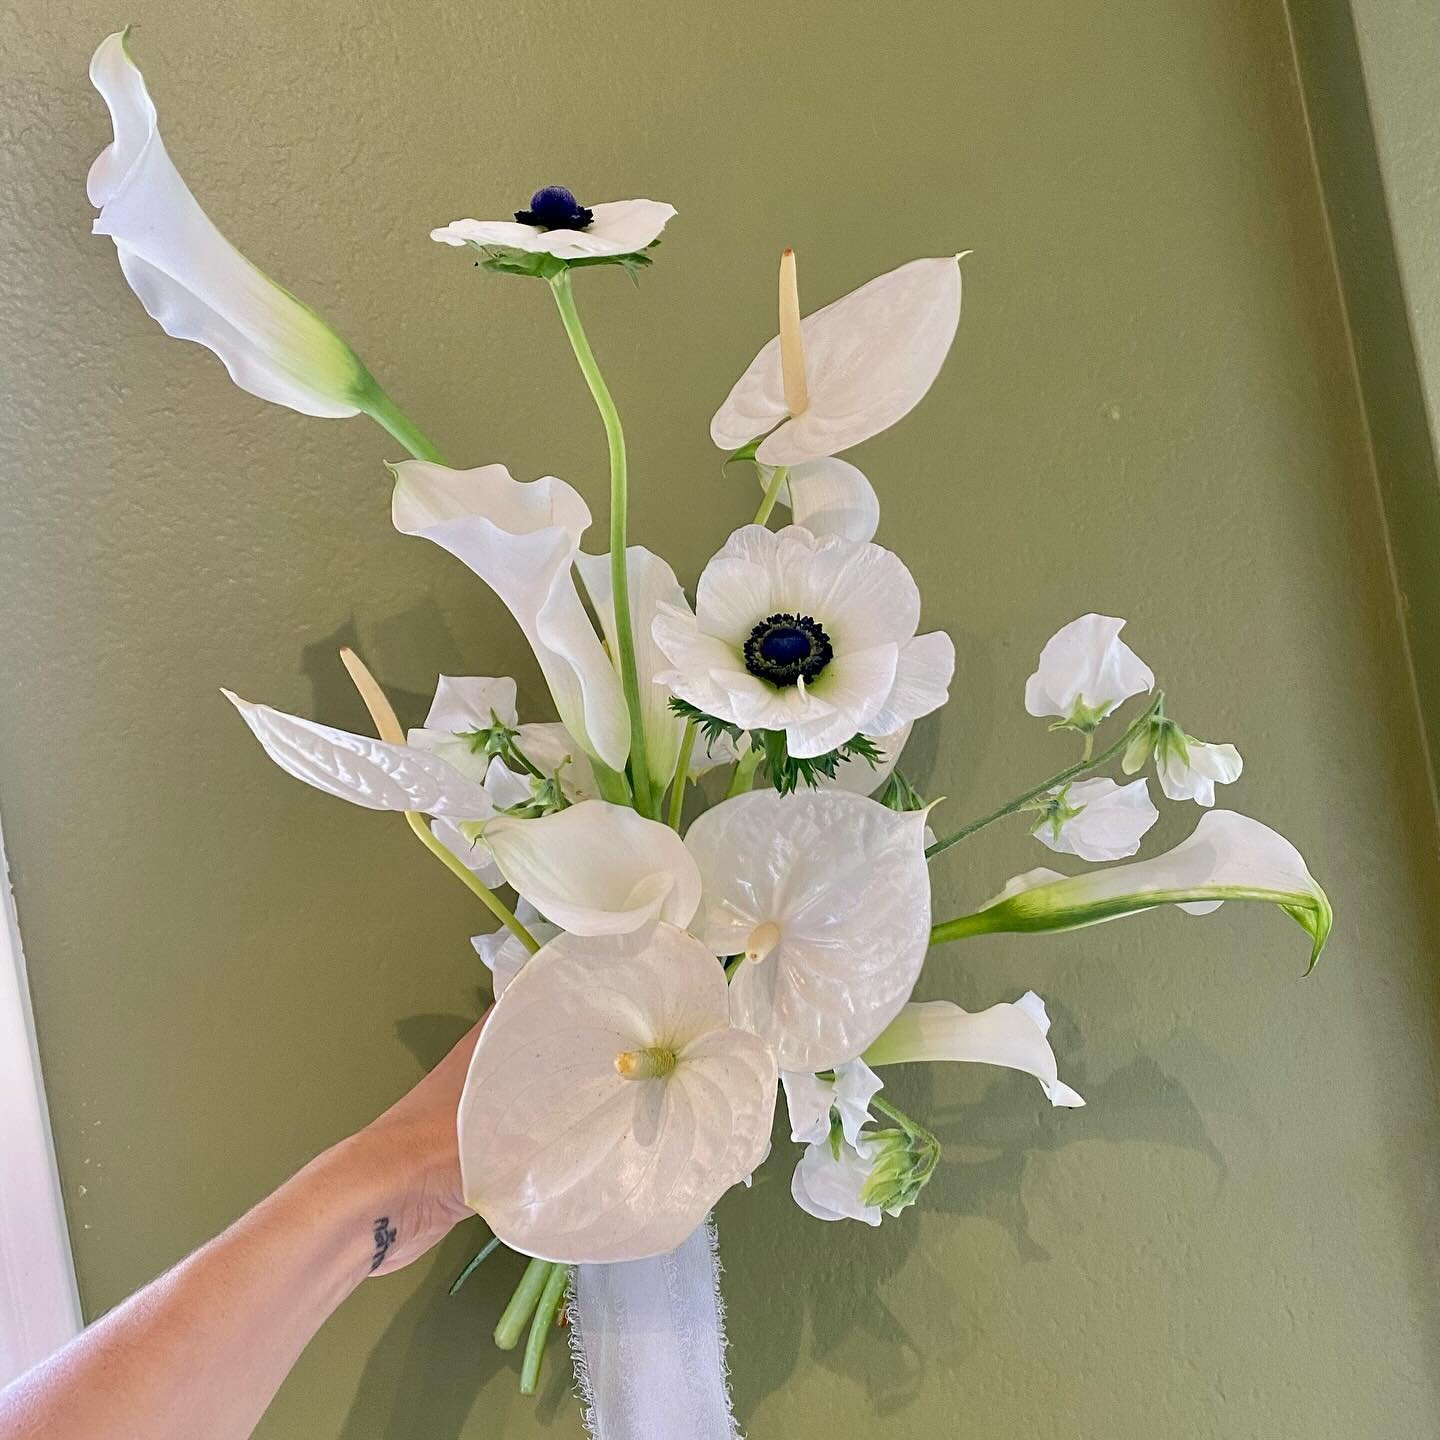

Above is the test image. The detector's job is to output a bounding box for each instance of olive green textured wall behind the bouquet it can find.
[0,0,1440,1440]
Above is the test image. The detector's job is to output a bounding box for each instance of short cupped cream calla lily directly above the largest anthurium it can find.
[484,801,700,935]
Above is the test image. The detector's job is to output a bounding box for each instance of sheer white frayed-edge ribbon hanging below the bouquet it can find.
[570,1221,740,1440]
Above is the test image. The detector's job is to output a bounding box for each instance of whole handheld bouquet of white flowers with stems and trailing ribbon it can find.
[89,35,1331,1437]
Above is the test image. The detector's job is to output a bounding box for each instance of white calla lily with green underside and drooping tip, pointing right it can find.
[961,811,1333,969]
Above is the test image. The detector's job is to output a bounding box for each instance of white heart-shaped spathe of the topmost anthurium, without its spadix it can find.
[710,255,960,465]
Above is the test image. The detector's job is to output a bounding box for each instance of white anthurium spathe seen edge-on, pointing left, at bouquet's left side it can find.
[220,690,495,819]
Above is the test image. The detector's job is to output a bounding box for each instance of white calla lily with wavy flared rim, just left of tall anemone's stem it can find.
[390,461,629,770]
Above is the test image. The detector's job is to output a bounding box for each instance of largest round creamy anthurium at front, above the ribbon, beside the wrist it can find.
[459,921,776,1264]
